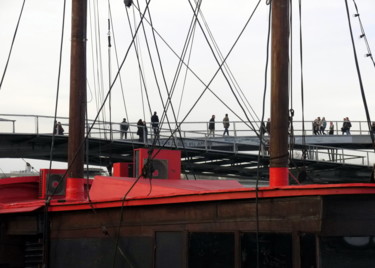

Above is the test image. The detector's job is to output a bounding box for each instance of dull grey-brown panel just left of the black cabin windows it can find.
[155,232,185,268]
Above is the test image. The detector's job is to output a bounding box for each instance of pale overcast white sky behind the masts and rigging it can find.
[0,0,375,172]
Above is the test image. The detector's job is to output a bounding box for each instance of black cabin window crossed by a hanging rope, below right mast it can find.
[241,233,292,268]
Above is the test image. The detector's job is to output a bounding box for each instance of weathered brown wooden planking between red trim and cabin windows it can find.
[51,196,322,238]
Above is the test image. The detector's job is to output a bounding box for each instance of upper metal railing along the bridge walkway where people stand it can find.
[0,114,375,139]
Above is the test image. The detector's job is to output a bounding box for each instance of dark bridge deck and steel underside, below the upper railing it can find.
[0,133,372,181]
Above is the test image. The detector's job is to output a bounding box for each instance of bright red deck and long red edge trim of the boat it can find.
[0,176,375,213]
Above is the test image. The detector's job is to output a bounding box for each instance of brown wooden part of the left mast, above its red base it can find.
[68,0,87,178]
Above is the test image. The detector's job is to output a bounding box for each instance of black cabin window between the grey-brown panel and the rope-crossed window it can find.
[188,233,235,268]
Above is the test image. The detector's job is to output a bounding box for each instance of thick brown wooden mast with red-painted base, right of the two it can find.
[270,0,289,187]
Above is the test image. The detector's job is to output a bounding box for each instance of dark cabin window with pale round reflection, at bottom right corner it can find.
[320,236,375,268]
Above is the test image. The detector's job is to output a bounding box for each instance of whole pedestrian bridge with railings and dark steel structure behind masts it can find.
[0,114,375,182]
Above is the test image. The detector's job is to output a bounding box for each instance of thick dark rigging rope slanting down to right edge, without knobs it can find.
[345,0,375,150]
